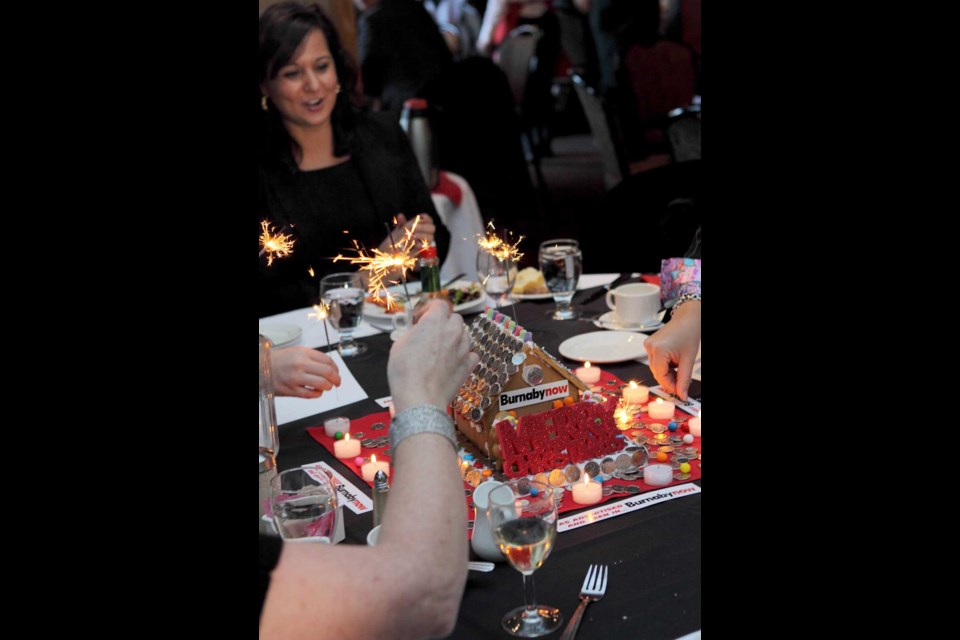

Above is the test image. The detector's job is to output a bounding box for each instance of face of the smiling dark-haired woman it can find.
[261,29,338,128]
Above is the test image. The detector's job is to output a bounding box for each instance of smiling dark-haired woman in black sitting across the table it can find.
[257,2,449,317]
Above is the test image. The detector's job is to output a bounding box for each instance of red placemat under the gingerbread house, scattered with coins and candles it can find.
[307,371,701,519]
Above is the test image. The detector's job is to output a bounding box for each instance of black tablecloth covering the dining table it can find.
[277,291,701,640]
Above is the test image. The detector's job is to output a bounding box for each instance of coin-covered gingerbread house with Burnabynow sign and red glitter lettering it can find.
[453,308,622,477]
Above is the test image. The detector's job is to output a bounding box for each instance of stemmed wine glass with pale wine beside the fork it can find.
[487,478,563,638]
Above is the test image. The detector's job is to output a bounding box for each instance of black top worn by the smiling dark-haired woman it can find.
[257,114,450,317]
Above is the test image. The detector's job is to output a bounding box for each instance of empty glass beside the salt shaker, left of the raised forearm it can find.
[270,467,337,543]
